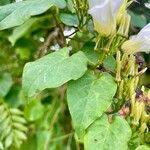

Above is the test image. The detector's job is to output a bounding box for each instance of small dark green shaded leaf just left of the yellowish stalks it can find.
[103,55,116,72]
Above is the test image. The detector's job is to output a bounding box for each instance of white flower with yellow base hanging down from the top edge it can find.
[89,0,124,36]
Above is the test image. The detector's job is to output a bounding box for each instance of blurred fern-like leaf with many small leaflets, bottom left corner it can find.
[0,99,28,149]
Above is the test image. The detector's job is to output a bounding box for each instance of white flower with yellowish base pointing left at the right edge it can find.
[122,23,150,54]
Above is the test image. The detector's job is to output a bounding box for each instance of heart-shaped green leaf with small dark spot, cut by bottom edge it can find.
[84,115,131,150]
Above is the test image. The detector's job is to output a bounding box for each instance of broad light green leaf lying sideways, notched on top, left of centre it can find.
[23,48,87,96]
